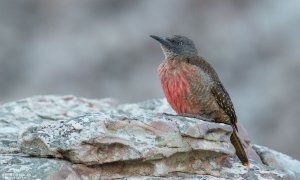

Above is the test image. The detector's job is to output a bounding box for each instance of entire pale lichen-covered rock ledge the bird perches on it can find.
[0,95,300,180]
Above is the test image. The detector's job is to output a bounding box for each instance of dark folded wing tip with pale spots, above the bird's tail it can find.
[211,82,238,130]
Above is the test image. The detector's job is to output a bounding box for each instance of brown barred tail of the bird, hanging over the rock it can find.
[230,129,249,166]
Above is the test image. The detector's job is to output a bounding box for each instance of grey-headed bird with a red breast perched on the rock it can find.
[150,35,250,166]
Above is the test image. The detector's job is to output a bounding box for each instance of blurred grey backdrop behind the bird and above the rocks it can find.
[0,0,300,159]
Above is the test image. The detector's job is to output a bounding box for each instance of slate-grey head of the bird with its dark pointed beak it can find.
[150,35,198,58]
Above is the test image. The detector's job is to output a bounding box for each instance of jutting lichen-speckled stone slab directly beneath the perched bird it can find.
[20,105,234,165]
